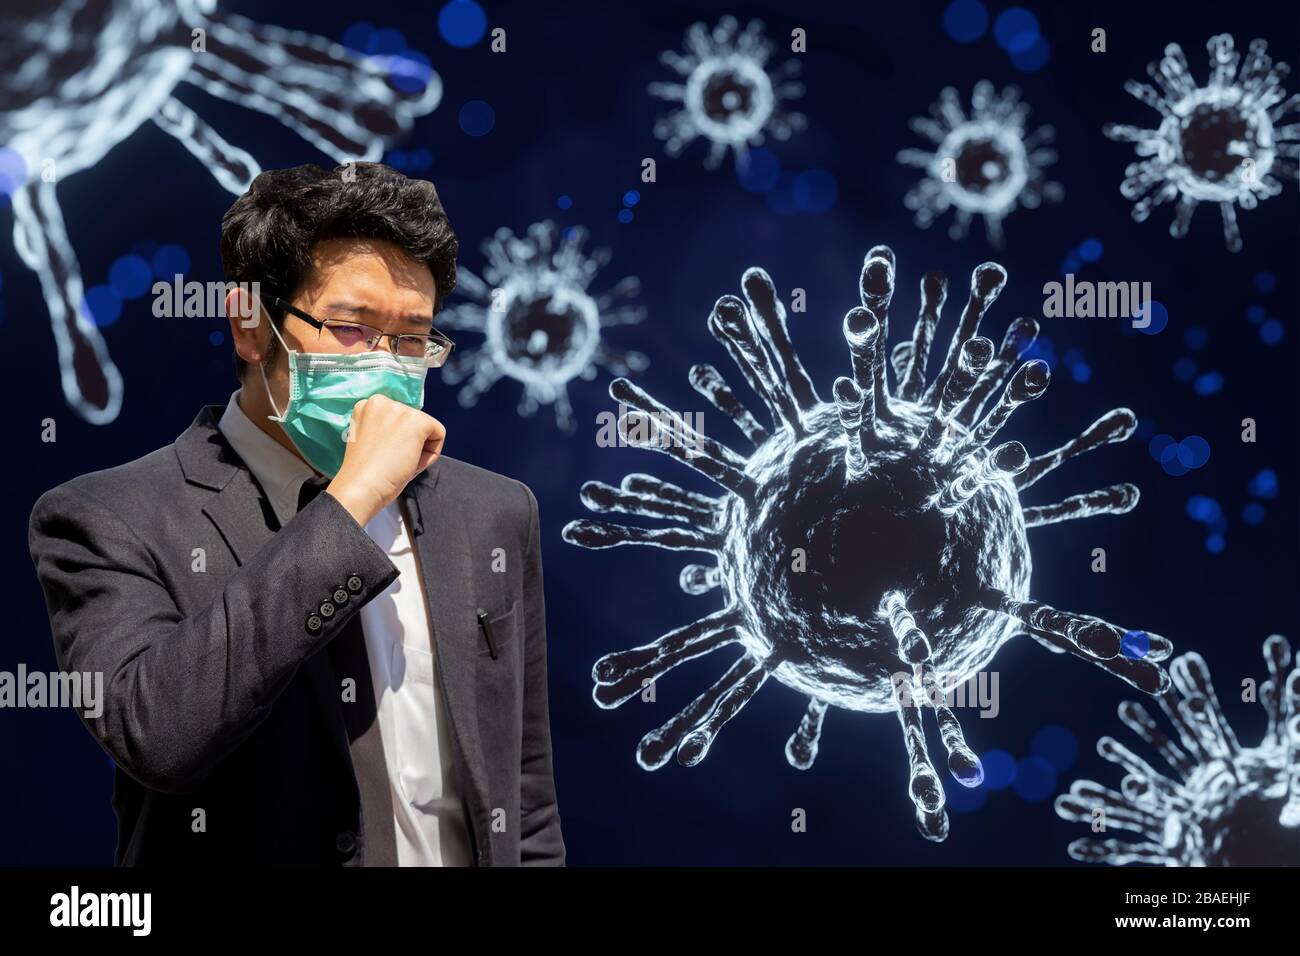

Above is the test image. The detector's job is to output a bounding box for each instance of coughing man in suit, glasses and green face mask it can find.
[29,163,564,866]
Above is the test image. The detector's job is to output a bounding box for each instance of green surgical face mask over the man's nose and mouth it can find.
[257,323,429,477]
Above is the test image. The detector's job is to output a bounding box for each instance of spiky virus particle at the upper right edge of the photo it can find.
[1102,34,1300,252]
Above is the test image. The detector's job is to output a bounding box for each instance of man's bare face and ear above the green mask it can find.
[241,239,436,410]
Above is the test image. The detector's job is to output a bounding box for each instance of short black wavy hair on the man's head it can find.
[221,163,460,381]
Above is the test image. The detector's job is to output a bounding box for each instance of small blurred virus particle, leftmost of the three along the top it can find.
[650,17,806,169]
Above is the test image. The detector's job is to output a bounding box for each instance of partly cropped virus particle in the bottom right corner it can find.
[1056,635,1300,866]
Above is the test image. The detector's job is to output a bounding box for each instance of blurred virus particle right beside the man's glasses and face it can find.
[438,221,650,433]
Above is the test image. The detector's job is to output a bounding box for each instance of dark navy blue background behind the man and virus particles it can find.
[0,0,1300,865]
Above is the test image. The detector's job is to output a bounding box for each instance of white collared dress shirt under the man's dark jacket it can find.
[218,389,473,866]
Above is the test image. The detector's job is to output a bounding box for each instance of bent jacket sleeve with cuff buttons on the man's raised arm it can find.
[27,481,398,792]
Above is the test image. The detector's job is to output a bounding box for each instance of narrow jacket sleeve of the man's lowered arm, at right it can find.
[519,483,564,866]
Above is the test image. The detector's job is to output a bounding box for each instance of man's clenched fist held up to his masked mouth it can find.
[325,395,447,527]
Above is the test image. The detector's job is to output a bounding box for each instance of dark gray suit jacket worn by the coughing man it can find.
[29,406,564,866]
